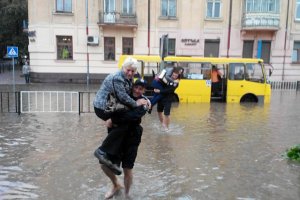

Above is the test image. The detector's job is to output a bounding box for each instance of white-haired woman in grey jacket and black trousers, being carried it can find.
[94,57,151,198]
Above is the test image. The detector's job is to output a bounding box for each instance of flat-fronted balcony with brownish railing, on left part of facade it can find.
[98,12,138,28]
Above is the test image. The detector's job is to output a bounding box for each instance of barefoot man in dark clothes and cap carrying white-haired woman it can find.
[99,80,147,199]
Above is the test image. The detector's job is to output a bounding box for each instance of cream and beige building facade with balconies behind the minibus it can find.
[28,0,300,82]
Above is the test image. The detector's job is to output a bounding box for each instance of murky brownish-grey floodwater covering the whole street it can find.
[0,91,300,200]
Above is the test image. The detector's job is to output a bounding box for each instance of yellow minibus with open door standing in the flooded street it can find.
[119,55,271,103]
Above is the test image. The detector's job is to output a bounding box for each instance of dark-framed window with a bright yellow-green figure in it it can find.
[56,36,73,60]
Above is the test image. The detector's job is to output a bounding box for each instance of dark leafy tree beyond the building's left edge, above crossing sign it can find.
[0,0,28,59]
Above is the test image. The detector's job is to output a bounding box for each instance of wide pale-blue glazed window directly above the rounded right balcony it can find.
[245,0,280,13]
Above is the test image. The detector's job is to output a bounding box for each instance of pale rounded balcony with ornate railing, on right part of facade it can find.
[242,13,280,31]
